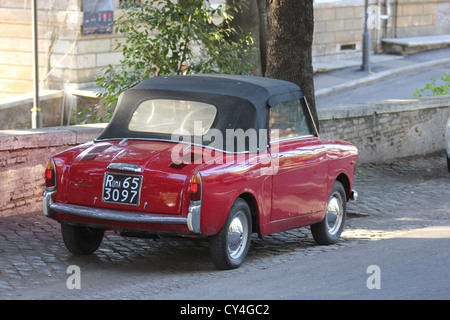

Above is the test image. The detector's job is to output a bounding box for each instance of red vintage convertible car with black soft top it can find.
[43,75,358,269]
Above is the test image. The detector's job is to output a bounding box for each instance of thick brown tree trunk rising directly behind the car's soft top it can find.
[265,0,319,128]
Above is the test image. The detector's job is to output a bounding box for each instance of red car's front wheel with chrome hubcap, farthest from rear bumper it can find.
[311,181,347,245]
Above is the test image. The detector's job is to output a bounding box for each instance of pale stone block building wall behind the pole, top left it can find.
[0,0,122,98]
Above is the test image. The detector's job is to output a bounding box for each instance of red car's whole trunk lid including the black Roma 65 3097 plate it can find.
[67,140,196,214]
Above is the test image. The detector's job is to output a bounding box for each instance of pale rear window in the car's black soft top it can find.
[128,99,217,135]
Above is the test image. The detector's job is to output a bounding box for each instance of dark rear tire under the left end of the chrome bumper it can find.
[61,224,105,255]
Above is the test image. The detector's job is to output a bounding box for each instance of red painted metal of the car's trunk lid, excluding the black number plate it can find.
[67,141,189,214]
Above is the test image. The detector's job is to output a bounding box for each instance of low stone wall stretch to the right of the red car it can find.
[319,96,450,162]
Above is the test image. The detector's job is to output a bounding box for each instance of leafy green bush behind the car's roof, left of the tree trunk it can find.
[97,0,254,116]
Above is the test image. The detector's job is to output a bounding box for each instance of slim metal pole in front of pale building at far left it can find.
[31,0,42,128]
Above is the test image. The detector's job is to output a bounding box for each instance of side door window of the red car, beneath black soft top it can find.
[269,100,312,139]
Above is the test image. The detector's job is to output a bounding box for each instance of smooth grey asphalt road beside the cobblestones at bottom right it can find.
[137,226,450,300]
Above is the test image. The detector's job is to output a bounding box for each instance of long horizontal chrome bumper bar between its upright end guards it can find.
[48,202,187,224]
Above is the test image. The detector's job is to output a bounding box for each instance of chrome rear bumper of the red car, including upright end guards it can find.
[42,191,201,233]
